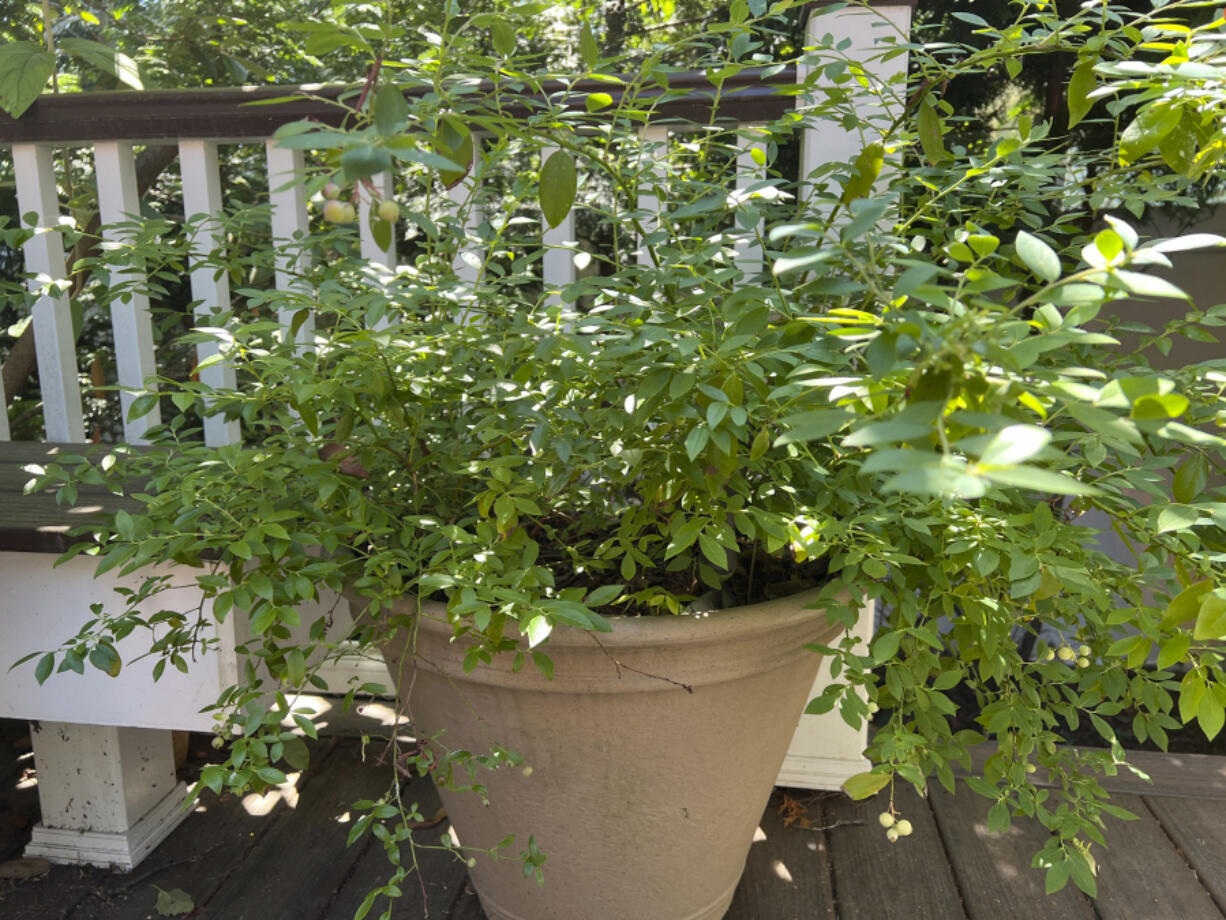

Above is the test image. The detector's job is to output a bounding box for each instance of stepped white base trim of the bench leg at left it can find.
[26,783,191,872]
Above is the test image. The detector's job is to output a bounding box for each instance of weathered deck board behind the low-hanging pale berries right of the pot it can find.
[823,786,966,920]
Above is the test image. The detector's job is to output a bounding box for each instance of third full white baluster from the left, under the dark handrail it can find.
[179,140,239,447]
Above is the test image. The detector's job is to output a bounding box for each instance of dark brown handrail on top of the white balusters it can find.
[0,66,796,145]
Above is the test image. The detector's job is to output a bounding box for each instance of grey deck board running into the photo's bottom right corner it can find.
[1095,795,1222,920]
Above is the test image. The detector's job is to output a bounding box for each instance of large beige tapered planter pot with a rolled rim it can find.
[370,592,841,920]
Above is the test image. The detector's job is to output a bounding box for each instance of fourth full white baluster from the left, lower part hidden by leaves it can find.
[265,140,315,348]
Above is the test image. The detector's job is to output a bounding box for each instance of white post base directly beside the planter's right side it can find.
[775,605,873,789]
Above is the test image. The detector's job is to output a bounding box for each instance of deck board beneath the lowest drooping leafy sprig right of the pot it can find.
[929,788,1094,920]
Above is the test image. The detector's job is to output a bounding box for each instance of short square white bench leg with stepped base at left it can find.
[26,721,189,871]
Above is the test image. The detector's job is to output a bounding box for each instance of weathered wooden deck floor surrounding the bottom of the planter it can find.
[0,721,1226,920]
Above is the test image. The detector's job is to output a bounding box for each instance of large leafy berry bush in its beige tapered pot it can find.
[21,1,1226,919]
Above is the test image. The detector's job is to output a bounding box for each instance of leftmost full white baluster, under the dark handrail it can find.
[5,144,85,443]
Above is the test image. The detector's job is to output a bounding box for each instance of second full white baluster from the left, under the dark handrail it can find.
[93,141,162,444]
